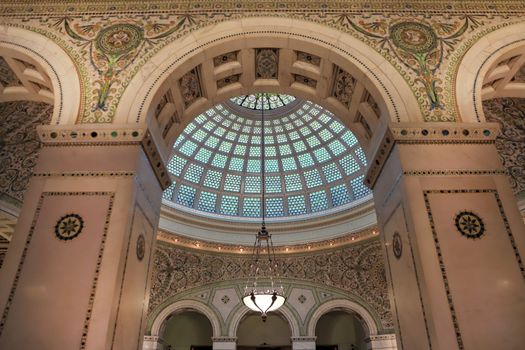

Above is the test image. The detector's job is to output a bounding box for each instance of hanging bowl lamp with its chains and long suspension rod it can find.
[242,93,286,322]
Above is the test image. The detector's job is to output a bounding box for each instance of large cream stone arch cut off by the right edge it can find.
[455,23,525,123]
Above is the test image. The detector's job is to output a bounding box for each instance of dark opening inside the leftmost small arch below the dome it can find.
[162,311,213,350]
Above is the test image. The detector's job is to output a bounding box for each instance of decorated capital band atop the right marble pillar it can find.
[364,122,500,188]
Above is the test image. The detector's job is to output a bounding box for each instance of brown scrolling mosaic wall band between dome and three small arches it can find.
[149,241,393,328]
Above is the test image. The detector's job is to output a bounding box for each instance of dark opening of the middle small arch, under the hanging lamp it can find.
[237,313,292,350]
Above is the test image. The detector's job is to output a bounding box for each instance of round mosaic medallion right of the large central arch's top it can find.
[390,22,437,54]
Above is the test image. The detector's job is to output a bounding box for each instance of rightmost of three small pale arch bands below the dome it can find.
[307,299,378,337]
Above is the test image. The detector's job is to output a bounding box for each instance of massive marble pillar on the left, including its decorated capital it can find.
[0,125,169,350]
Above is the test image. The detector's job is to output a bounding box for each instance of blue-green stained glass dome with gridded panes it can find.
[163,95,371,219]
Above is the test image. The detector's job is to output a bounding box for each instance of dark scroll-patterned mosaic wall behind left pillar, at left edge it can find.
[0,101,53,204]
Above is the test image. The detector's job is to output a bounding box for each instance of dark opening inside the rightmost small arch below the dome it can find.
[315,311,366,350]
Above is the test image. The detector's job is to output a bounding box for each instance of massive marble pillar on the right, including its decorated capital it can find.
[366,123,525,350]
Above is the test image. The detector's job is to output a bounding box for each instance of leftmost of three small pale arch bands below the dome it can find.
[151,300,221,337]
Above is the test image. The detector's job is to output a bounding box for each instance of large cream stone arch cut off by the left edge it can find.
[0,25,81,124]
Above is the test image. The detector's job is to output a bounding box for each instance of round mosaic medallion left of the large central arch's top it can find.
[95,23,144,56]
